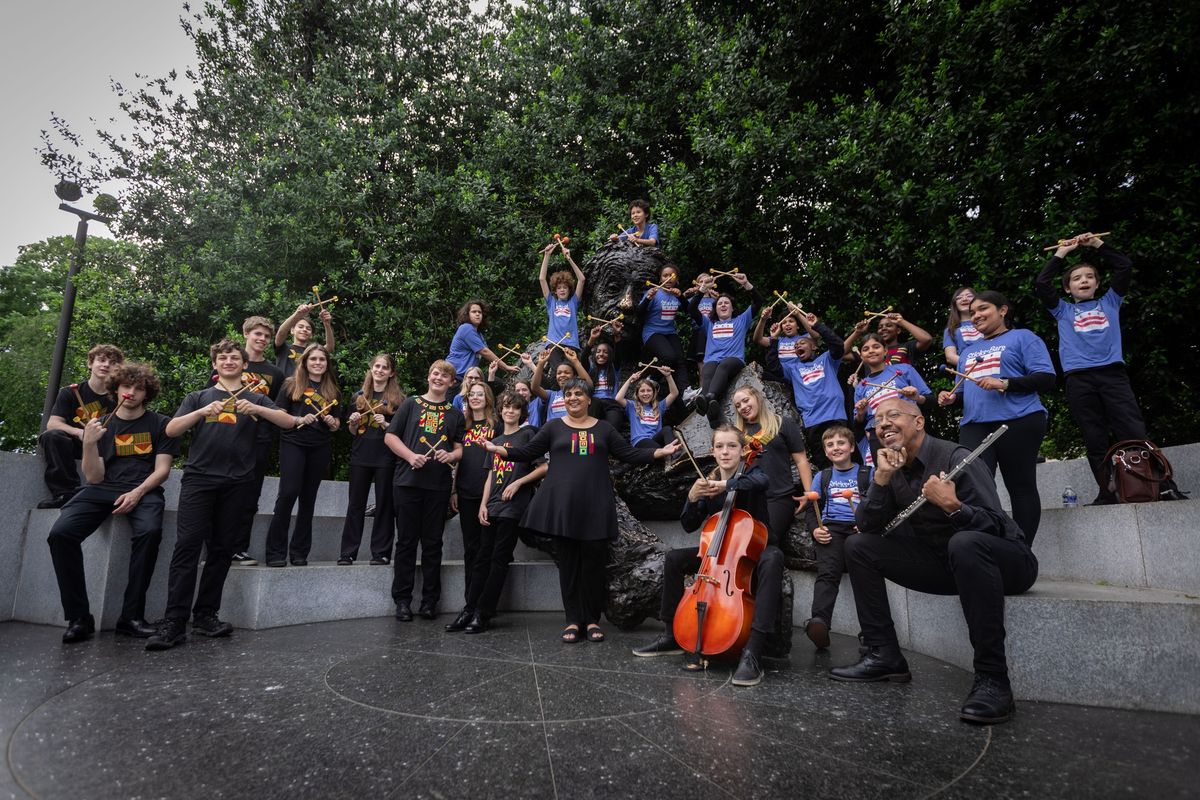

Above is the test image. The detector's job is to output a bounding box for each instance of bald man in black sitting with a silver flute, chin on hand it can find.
[830,398,1038,724]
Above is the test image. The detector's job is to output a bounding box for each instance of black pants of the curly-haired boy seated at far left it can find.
[47,486,163,621]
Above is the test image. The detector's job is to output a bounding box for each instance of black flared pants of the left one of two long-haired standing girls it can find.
[266,440,330,564]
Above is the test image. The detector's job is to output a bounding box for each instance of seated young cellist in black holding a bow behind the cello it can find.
[634,425,784,686]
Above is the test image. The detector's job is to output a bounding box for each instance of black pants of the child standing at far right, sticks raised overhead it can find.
[1065,363,1146,499]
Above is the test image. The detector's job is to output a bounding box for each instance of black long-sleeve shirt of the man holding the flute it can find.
[854,434,1025,545]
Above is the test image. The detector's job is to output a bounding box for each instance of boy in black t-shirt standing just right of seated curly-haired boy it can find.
[146,339,298,650]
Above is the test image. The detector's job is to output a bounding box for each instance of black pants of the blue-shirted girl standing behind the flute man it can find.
[959,411,1046,547]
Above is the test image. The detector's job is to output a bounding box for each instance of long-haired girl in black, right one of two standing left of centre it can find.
[337,353,404,566]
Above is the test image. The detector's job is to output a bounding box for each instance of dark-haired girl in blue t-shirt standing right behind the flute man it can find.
[937,290,1055,547]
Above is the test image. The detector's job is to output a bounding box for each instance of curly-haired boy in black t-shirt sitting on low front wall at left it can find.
[47,363,179,644]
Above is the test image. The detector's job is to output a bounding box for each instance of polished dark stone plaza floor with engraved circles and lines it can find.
[0,613,1200,800]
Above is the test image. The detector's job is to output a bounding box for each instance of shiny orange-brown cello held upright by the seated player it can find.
[673,440,767,664]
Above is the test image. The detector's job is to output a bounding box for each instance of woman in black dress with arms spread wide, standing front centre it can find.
[486,378,679,644]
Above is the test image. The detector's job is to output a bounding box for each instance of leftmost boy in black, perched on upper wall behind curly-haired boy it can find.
[37,344,125,509]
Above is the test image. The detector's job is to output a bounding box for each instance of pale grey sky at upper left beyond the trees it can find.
[0,0,196,266]
